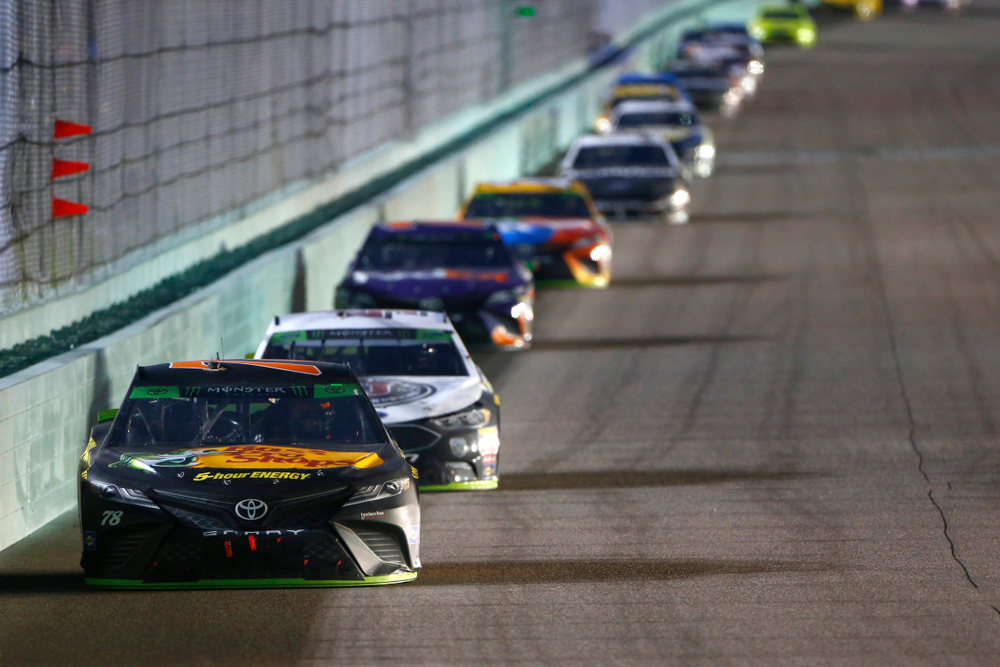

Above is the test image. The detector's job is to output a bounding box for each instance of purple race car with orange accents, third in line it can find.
[334,221,535,351]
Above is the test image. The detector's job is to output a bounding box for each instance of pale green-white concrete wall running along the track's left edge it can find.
[0,0,758,549]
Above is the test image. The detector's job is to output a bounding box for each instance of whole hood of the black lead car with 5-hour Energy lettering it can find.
[93,444,405,499]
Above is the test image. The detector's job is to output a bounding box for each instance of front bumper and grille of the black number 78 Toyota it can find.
[81,484,420,589]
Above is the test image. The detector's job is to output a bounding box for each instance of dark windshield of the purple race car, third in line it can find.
[357,234,511,271]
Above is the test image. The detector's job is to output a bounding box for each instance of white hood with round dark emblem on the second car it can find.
[360,375,483,425]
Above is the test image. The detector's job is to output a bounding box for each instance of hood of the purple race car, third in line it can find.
[345,269,524,299]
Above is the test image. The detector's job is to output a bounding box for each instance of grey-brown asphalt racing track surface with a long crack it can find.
[0,7,1000,667]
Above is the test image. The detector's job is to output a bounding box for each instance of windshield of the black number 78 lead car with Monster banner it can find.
[108,385,385,450]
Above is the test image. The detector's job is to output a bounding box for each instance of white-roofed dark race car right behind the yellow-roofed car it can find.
[560,132,691,224]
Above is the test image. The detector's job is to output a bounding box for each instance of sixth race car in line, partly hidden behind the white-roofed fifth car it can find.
[611,102,715,177]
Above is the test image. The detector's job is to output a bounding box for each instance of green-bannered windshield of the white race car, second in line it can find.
[264,329,469,377]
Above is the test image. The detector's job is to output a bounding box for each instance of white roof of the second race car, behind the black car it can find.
[269,308,455,335]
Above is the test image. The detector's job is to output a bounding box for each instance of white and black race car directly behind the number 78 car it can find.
[256,310,500,491]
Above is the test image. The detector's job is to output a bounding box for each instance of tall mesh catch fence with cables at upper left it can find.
[0,0,598,313]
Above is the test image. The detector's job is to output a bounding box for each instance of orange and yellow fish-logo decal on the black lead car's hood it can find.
[110,445,383,472]
